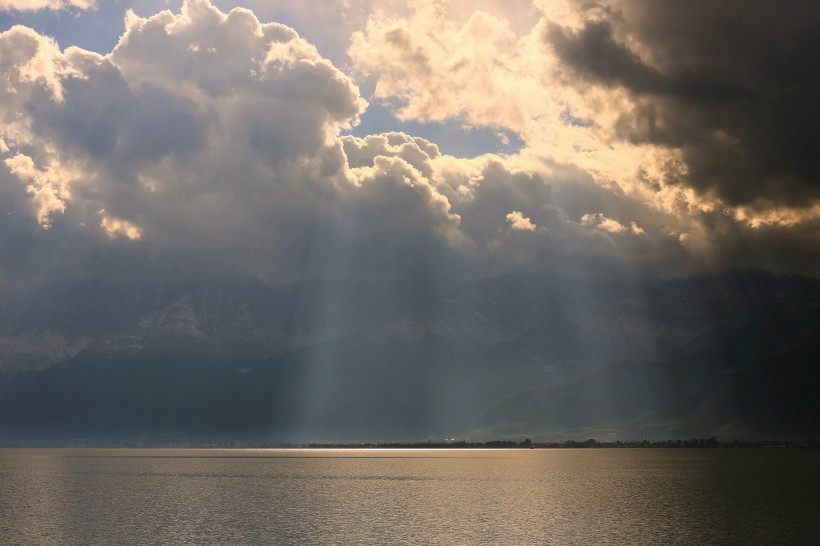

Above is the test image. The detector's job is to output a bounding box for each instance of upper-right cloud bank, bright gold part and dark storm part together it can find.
[350,0,820,272]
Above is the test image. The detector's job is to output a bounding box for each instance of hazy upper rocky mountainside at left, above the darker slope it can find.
[0,279,422,370]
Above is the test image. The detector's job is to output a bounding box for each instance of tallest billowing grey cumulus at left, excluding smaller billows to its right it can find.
[0,0,365,276]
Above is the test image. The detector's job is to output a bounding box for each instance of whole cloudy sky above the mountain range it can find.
[0,0,820,290]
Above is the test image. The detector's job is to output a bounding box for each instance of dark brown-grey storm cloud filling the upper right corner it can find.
[545,0,820,210]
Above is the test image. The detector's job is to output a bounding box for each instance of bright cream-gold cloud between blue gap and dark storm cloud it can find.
[349,2,701,223]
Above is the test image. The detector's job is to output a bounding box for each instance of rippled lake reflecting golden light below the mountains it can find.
[0,449,820,545]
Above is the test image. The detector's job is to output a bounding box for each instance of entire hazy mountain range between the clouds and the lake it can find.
[0,271,820,441]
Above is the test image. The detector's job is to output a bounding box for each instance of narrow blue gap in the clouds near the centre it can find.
[350,101,524,158]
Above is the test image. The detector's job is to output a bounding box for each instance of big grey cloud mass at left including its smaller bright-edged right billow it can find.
[0,0,500,280]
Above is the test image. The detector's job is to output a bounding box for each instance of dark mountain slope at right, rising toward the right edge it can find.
[475,302,820,438]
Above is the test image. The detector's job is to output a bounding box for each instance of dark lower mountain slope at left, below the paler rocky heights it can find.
[0,328,491,441]
